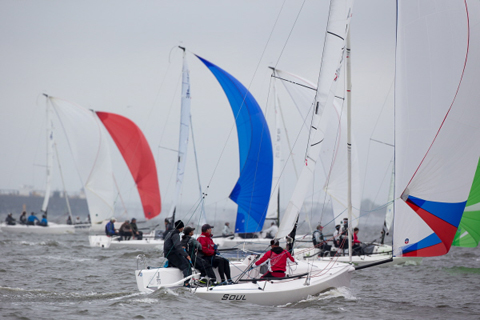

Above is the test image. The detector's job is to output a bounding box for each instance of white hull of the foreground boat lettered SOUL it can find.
[135,256,354,305]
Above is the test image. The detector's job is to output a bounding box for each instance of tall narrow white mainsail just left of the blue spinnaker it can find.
[168,52,191,218]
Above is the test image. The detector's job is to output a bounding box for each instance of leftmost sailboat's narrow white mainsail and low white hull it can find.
[0,95,75,234]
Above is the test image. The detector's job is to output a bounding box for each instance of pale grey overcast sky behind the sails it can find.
[0,0,396,220]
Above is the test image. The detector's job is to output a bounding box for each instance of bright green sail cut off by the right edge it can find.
[452,161,480,248]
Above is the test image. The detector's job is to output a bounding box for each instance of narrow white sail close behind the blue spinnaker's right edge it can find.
[265,79,283,219]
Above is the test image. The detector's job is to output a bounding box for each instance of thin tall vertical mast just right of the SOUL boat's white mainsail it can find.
[345,31,353,263]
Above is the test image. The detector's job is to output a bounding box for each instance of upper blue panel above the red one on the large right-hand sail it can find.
[408,196,467,227]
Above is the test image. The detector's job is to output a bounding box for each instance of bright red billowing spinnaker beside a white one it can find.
[97,111,161,219]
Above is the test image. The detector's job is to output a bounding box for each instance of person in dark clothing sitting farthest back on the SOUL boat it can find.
[163,220,192,285]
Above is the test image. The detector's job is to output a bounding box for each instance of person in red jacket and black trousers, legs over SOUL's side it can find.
[197,223,233,285]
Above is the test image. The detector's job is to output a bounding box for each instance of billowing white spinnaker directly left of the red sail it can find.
[49,97,115,224]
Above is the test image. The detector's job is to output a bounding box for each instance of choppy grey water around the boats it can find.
[0,229,480,319]
